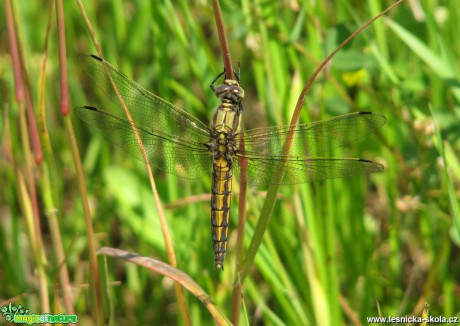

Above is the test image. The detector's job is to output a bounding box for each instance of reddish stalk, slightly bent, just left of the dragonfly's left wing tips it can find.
[55,0,105,325]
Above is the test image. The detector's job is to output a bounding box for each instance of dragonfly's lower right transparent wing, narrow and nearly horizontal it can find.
[234,155,383,185]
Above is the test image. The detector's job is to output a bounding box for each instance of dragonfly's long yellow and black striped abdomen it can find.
[211,157,233,269]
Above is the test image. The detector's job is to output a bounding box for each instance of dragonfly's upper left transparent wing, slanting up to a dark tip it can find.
[78,54,209,142]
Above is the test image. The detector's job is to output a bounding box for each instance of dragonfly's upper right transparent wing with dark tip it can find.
[238,112,386,157]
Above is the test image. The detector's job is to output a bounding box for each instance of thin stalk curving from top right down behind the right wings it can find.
[241,0,404,281]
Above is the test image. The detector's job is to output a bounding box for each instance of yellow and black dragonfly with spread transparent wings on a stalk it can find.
[74,54,386,269]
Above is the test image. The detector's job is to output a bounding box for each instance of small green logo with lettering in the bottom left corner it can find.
[0,302,78,325]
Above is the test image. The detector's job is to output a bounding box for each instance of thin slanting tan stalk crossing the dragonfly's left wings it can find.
[77,1,192,325]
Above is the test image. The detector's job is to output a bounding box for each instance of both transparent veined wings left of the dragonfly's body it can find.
[75,55,212,179]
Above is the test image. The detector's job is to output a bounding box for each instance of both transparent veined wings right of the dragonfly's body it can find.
[234,112,386,185]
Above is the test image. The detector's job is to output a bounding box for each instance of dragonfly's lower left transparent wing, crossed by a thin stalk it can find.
[75,106,212,179]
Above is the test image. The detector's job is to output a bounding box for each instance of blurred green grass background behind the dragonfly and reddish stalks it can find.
[0,0,460,325]
